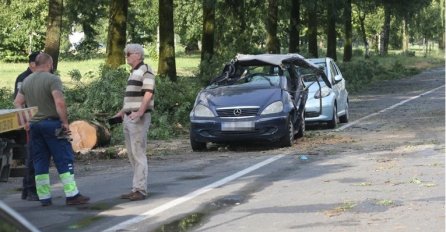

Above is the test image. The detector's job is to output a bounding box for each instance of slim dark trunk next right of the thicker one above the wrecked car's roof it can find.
[288,0,300,53]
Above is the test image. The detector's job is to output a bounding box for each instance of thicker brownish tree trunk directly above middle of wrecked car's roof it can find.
[266,0,280,53]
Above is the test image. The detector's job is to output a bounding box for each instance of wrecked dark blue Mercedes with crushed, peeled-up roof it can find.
[190,54,329,151]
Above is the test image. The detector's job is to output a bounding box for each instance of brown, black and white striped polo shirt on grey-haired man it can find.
[122,62,155,112]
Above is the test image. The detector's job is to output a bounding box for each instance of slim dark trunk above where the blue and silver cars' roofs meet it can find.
[307,0,319,58]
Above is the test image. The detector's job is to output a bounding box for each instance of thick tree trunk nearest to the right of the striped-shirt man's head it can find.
[158,0,177,81]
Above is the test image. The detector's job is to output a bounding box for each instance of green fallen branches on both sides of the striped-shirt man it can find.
[65,66,200,142]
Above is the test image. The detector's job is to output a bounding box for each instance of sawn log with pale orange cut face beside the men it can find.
[70,120,111,152]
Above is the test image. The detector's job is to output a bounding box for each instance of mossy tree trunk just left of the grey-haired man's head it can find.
[106,0,125,68]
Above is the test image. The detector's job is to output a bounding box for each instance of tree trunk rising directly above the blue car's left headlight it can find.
[201,0,215,63]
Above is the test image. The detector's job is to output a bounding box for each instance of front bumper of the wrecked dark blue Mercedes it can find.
[190,116,288,143]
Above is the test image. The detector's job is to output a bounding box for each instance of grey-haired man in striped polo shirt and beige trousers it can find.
[115,44,155,201]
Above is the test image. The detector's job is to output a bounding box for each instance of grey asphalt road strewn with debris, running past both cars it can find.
[0,68,445,232]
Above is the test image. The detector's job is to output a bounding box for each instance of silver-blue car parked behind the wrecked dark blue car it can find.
[301,57,349,129]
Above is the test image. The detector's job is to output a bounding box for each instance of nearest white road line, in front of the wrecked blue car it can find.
[104,154,286,232]
